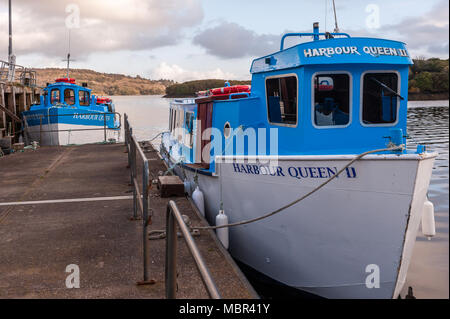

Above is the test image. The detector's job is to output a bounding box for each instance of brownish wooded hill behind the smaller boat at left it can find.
[35,68,174,95]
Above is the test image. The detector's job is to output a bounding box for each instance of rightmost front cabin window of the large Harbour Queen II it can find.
[362,72,402,124]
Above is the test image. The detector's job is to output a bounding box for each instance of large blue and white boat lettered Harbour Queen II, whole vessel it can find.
[161,24,437,298]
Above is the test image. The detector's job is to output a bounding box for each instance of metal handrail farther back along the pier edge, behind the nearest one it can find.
[124,114,155,285]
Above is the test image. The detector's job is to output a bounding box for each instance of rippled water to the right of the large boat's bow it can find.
[403,101,449,298]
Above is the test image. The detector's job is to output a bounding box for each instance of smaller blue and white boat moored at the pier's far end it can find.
[22,76,120,145]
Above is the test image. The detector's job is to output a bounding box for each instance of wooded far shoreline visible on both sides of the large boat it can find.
[35,58,449,101]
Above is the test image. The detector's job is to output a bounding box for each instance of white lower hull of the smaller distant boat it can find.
[28,123,120,146]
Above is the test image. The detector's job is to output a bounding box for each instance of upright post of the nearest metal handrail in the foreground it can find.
[165,205,177,299]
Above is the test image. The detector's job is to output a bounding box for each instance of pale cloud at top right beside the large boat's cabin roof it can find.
[380,0,449,57]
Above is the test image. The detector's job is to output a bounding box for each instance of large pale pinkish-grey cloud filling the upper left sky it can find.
[0,0,203,58]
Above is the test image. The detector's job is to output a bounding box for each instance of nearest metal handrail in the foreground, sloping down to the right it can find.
[165,200,221,299]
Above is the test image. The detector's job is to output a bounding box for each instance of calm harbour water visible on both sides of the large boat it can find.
[113,96,449,298]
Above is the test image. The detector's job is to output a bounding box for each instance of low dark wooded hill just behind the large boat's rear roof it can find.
[164,79,251,97]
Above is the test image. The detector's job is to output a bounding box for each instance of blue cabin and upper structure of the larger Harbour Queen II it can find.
[163,25,412,172]
